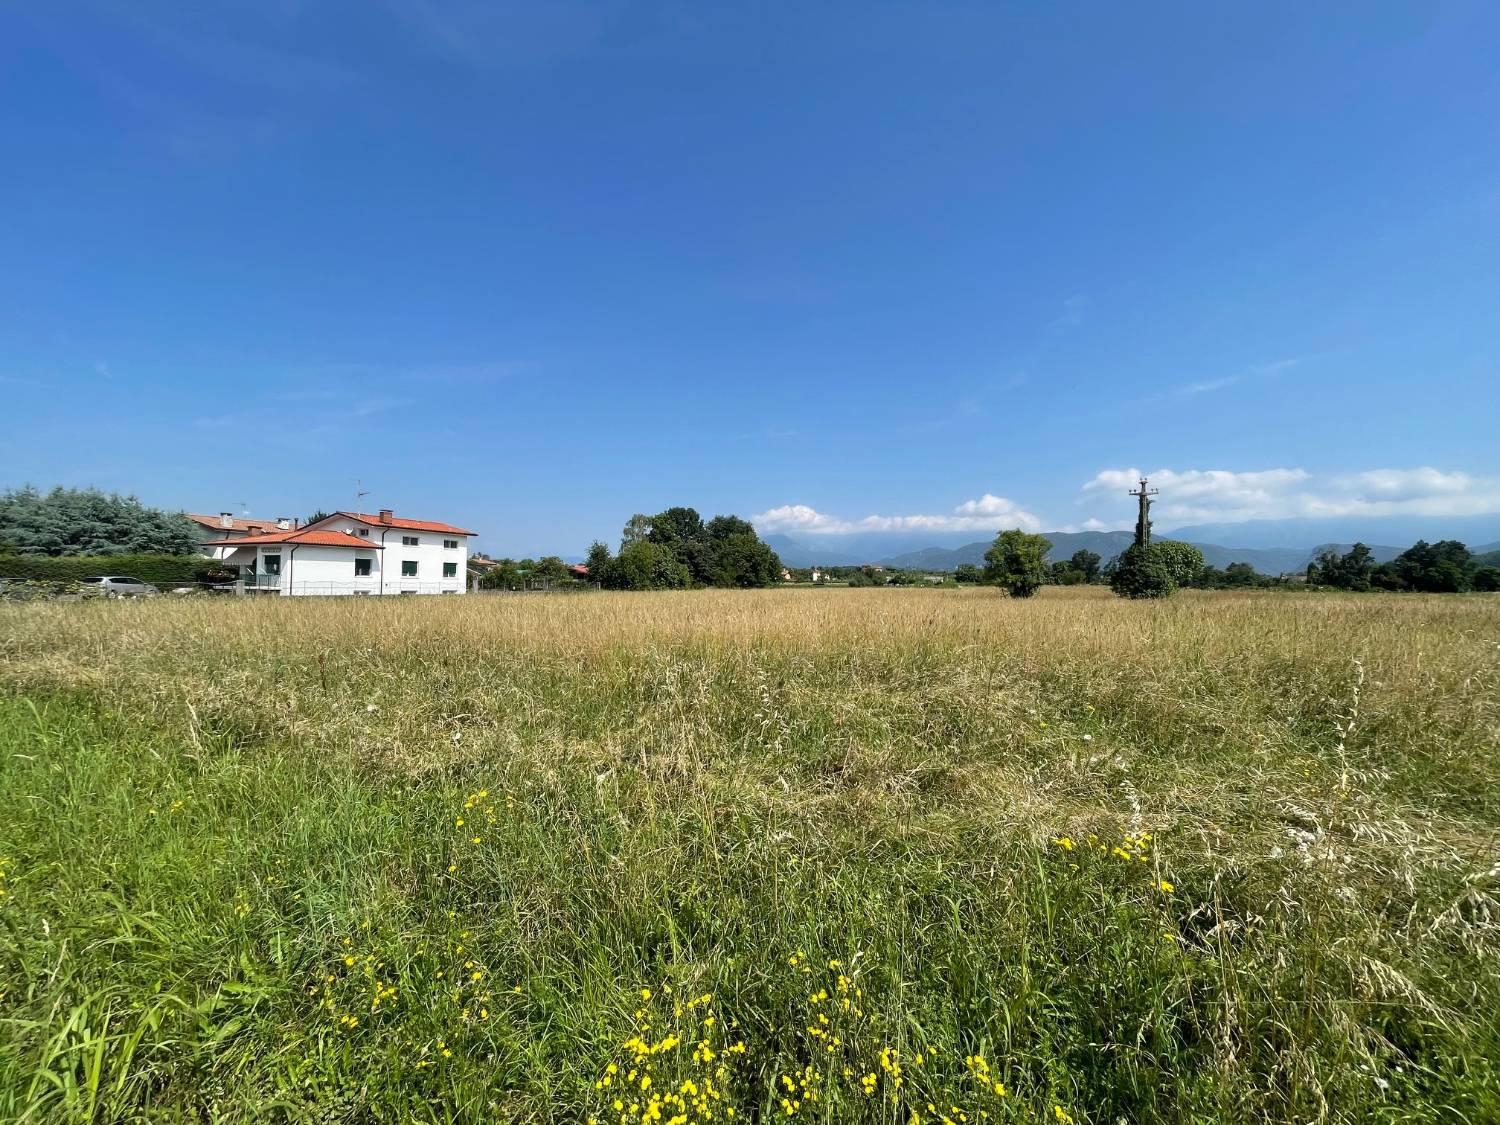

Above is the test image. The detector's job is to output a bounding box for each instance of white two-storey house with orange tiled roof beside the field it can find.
[206,509,474,596]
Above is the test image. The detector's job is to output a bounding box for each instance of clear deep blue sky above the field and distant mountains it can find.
[0,0,1500,555]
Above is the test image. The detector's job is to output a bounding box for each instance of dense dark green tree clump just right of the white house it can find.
[588,507,782,590]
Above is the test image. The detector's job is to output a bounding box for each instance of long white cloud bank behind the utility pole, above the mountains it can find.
[1083,467,1500,524]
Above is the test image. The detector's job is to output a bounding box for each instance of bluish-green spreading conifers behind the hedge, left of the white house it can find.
[0,488,200,555]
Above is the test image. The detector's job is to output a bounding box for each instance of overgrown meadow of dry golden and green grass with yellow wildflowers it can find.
[0,588,1500,1125]
